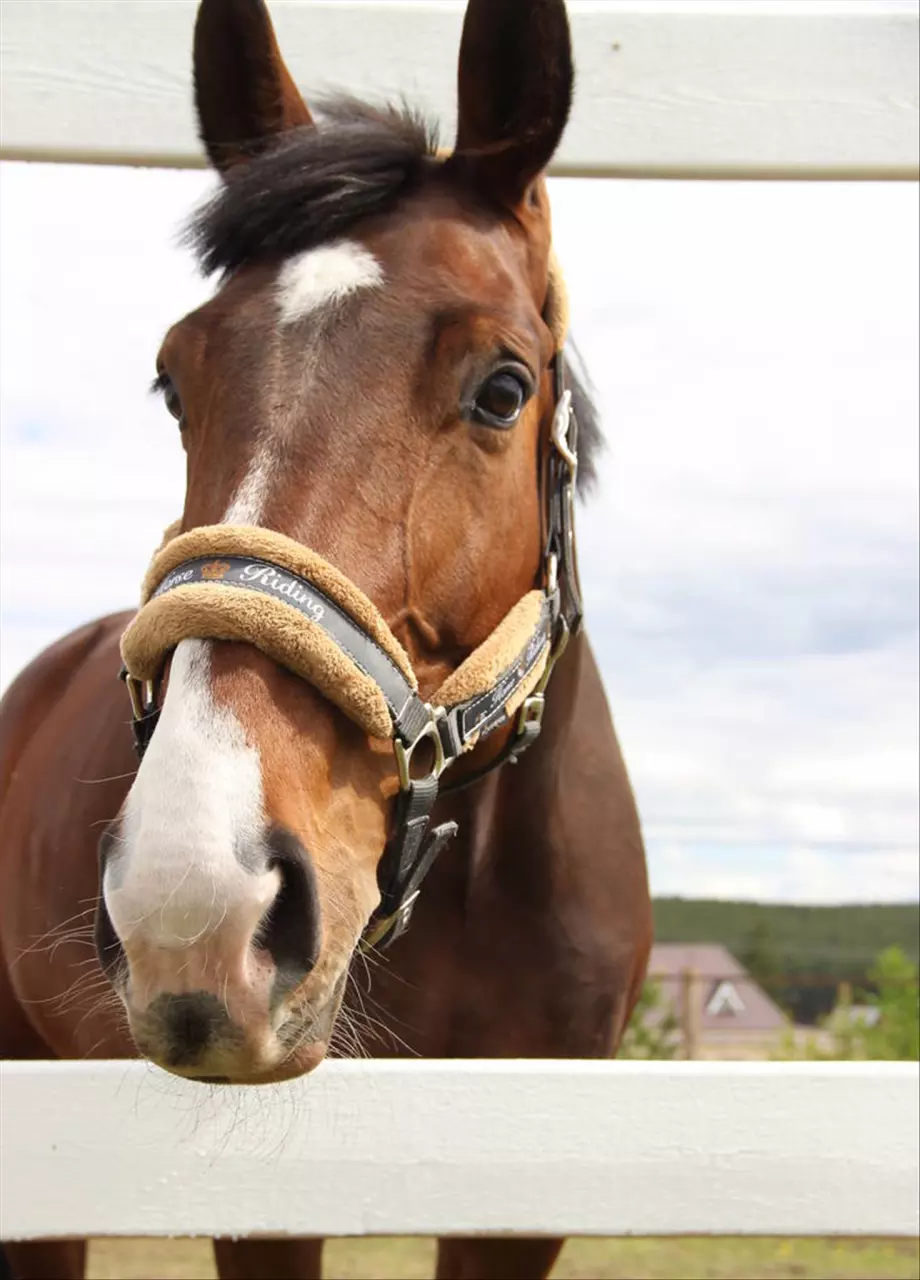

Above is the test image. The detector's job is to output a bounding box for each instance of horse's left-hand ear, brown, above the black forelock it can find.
[194,0,312,173]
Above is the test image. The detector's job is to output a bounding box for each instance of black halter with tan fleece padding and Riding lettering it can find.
[122,351,582,947]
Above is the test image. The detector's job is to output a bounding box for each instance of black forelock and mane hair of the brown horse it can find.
[184,97,603,493]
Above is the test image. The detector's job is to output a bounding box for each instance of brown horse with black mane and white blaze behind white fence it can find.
[0,0,651,1280]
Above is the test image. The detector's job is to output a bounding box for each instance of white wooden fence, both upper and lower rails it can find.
[0,0,920,1239]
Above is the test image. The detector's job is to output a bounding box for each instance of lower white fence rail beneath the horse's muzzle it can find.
[0,1061,920,1239]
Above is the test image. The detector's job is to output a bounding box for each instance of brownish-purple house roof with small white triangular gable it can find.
[649,942,788,1033]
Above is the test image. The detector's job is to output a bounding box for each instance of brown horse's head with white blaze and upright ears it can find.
[97,0,591,1080]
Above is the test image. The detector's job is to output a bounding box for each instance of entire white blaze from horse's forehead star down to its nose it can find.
[110,241,384,948]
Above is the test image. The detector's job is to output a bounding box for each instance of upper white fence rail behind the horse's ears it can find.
[0,0,920,178]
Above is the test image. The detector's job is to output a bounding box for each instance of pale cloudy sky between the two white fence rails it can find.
[0,163,920,902]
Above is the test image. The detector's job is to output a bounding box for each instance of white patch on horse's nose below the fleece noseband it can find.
[102,640,279,948]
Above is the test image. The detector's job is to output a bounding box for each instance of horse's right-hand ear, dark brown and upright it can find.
[454,0,573,205]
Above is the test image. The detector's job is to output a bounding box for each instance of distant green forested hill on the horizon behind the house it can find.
[654,897,920,1023]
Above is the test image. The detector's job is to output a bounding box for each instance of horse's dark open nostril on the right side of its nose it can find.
[258,826,320,989]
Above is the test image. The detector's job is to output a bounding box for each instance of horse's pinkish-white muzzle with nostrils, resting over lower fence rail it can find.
[96,827,347,1083]
